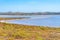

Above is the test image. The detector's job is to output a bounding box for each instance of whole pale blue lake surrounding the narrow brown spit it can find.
[0,15,60,27]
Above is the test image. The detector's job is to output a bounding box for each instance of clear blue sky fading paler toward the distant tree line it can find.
[0,0,60,12]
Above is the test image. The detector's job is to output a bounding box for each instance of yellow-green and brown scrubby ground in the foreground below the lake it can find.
[0,22,60,40]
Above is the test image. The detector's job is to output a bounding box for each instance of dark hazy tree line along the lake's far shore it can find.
[0,12,60,15]
